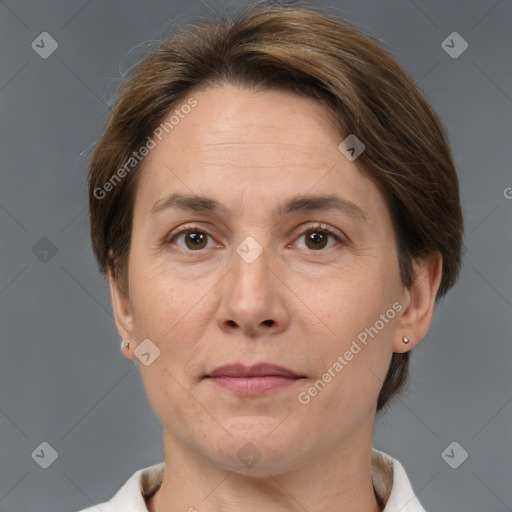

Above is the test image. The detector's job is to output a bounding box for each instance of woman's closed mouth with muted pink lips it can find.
[205,363,305,395]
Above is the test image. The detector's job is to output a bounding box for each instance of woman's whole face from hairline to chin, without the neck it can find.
[111,85,435,472]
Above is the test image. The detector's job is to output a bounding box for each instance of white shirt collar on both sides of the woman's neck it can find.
[76,448,425,512]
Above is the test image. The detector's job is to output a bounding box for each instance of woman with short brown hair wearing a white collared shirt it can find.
[79,2,462,512]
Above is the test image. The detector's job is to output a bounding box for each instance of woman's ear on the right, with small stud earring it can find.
[393,251,443,353]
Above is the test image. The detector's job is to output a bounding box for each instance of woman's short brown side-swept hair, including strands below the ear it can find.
[89,1,463,410]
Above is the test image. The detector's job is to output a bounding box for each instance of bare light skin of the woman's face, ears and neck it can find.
[109,84,442,512]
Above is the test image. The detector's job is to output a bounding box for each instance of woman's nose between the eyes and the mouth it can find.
[217,242,290,337]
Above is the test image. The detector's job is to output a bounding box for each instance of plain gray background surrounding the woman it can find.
[0,0,512,512]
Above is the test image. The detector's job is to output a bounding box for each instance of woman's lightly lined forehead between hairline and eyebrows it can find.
[136,85,388,224]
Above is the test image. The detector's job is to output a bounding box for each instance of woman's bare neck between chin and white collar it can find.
[147,418,382,512]
